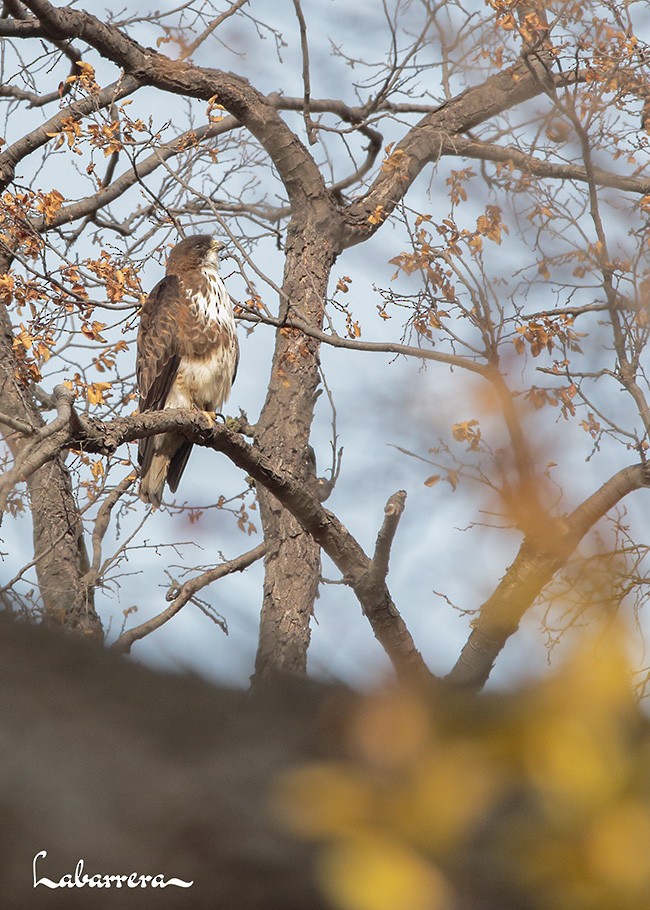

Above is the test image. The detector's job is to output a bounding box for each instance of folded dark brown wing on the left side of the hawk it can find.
[135,275,182,473]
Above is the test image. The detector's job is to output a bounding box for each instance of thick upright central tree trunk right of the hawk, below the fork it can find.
[255,219,337,677]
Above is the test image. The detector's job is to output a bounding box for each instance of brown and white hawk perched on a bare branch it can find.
[136,234,239,508]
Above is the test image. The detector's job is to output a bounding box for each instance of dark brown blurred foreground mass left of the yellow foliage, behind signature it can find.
[0,618,321,910]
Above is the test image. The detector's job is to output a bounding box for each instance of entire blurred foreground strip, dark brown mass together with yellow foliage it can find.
[0,617,650,910]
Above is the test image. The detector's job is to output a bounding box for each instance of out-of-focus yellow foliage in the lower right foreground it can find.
[275,625,650,910]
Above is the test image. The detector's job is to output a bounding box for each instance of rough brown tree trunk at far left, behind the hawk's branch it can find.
[0,296,102,636]
